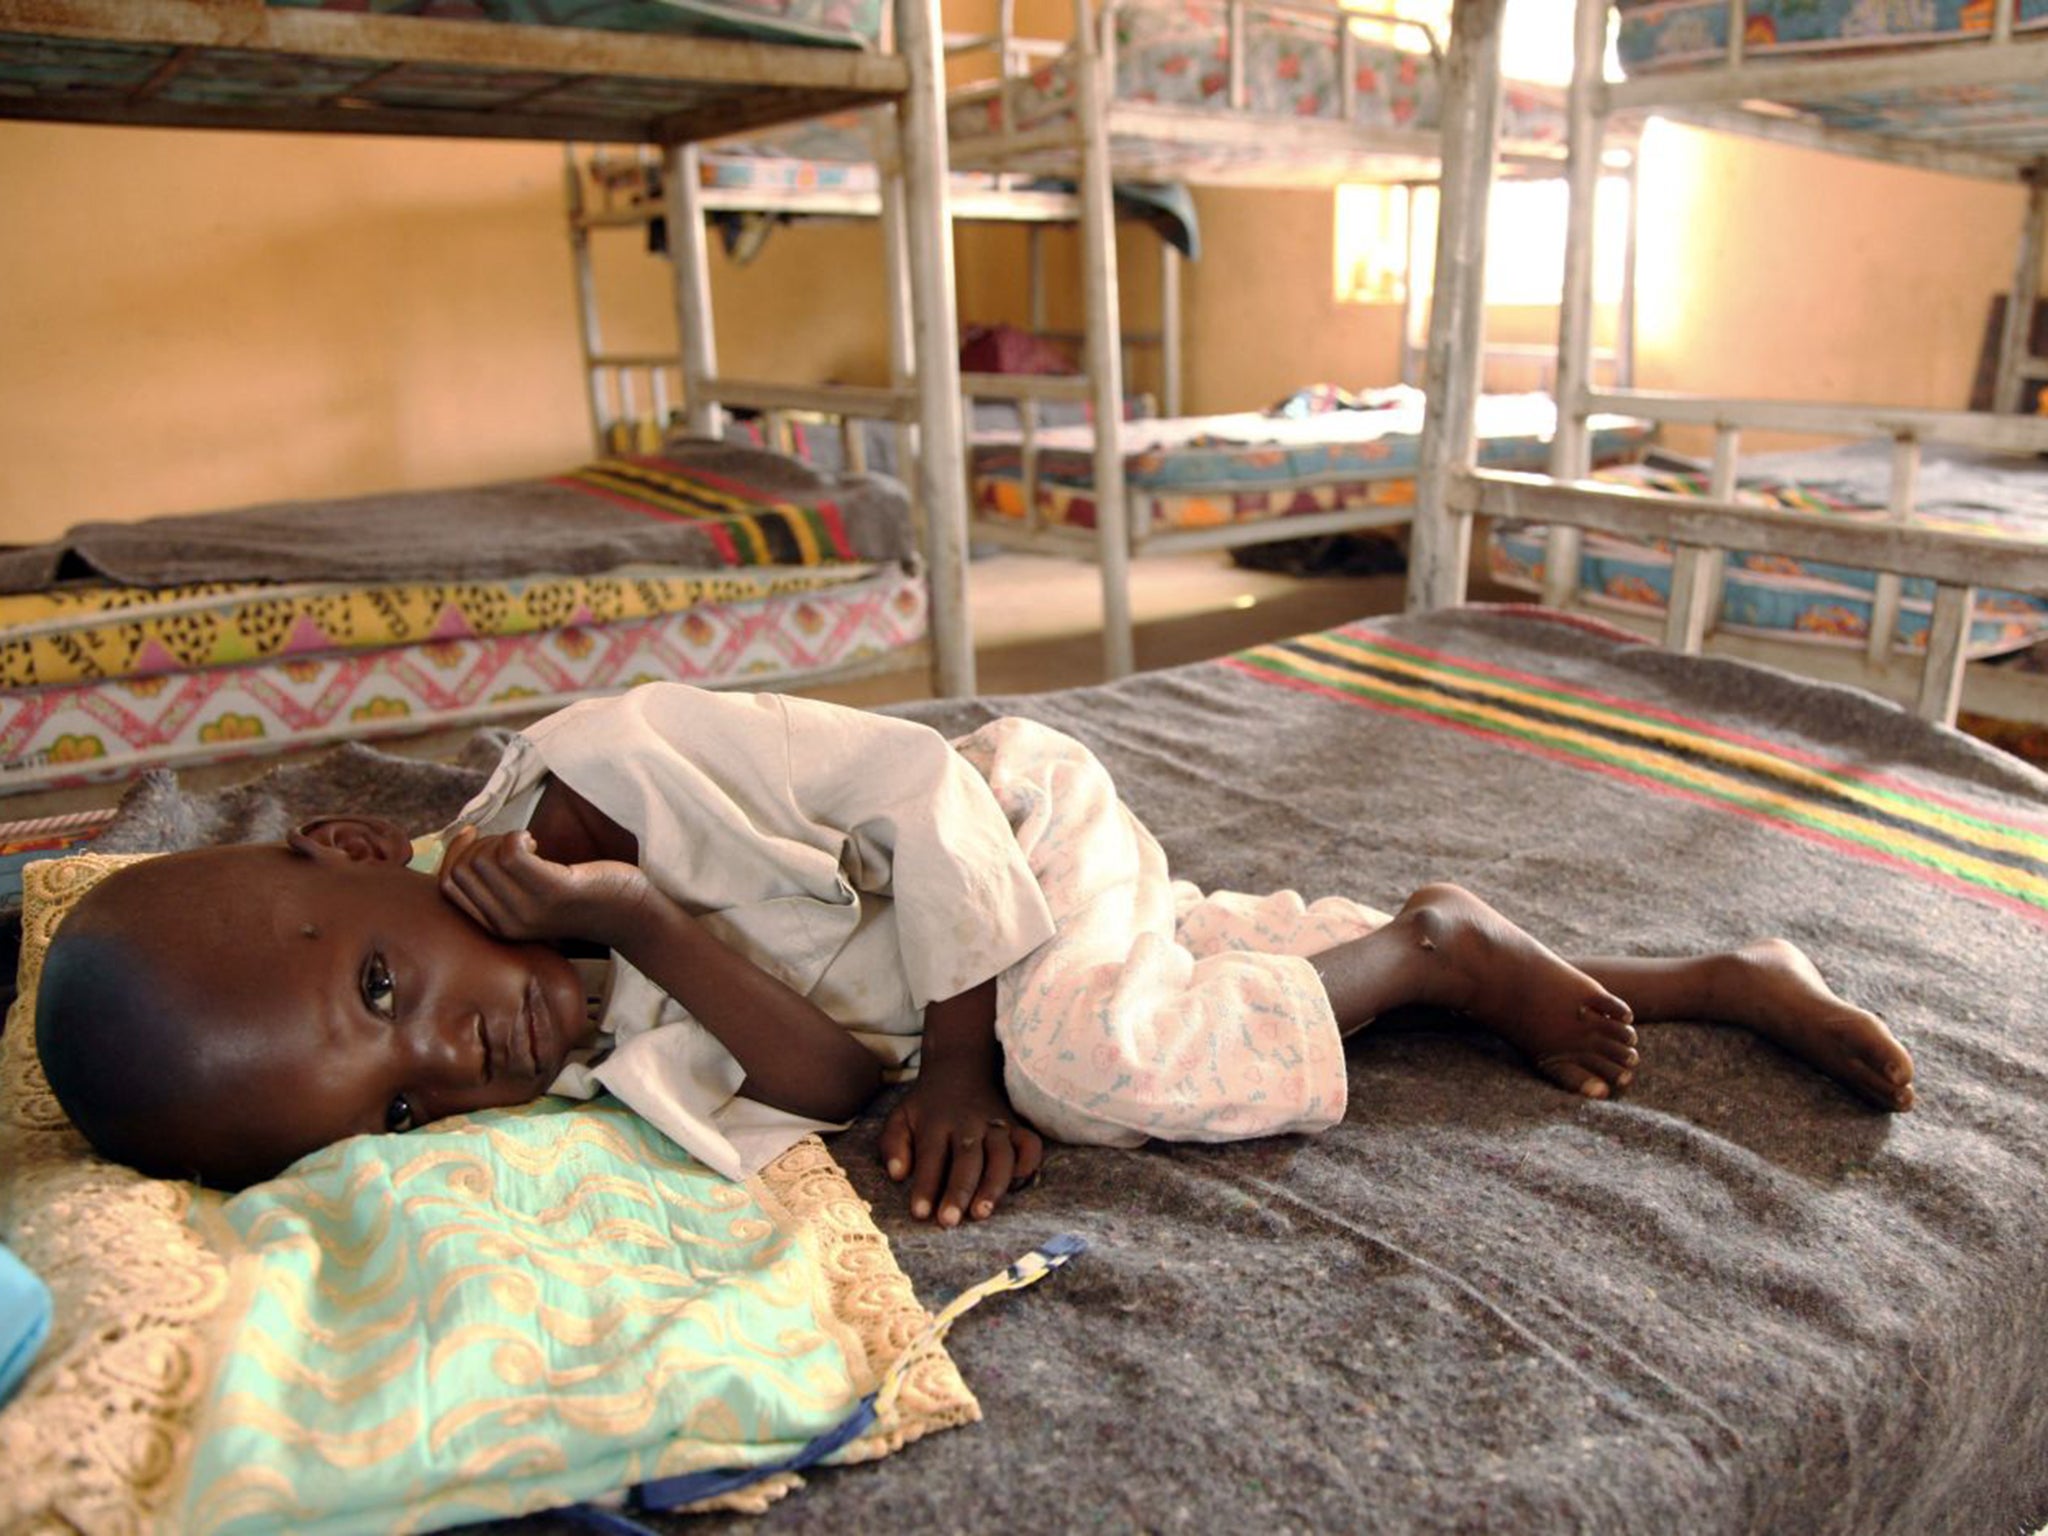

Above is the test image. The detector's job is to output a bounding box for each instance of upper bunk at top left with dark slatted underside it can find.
[0,0,913,143]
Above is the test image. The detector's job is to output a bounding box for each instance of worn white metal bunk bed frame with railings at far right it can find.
[1407,0,2048,725]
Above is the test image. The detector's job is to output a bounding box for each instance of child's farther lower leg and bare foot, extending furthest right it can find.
[1579,938,1913,1110]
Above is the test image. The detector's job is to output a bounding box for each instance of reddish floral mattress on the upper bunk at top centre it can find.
[948,0,1565,168]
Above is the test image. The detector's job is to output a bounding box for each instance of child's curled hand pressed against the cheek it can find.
[438,827,651,948]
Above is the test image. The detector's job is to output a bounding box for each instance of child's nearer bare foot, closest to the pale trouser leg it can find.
[1389,885,1636,1098]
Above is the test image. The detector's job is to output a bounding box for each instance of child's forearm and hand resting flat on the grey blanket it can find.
[881,981,1044,1227]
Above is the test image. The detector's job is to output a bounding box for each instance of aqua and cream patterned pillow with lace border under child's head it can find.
[0,854,979,1532]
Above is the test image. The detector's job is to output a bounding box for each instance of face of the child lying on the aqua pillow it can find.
[142,848,592,1182]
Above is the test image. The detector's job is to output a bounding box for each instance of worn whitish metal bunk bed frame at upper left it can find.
[0,0,975,696]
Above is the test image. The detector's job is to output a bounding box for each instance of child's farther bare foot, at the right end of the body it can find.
[1708,938,1913,1110]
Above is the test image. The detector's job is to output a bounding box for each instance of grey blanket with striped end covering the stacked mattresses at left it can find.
[0,438,913,592]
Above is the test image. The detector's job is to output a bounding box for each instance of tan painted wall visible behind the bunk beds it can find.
[0,72,2019,541]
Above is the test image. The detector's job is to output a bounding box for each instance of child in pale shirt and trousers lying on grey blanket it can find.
[37,684,1913,1225]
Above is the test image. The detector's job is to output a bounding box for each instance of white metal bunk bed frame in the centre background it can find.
[948,0,1605,678]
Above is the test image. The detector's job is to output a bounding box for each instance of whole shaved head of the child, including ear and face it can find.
[35,831,590,1188]
